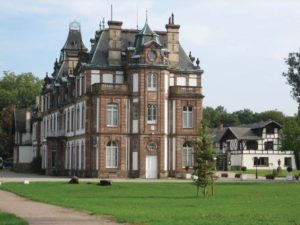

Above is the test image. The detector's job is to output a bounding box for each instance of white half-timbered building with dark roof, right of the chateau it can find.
[214,120,296,170]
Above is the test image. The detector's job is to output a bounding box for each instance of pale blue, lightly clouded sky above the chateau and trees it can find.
[0,0,300,115]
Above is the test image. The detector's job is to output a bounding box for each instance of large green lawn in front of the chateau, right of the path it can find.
[1,182,300,225]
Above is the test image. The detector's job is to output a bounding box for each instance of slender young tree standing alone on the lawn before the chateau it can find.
[193,126,216,197]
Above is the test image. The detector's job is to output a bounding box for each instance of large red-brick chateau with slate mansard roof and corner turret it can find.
[33,15,203,178]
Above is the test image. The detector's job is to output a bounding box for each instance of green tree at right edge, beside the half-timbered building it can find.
[282,117,300,169]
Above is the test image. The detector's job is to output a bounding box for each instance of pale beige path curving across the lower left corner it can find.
[0,190,131,225]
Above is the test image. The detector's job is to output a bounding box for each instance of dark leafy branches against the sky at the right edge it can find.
[282,52,300,114]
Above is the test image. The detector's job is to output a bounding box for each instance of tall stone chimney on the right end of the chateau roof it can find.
[166,13,180,66]
